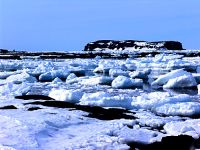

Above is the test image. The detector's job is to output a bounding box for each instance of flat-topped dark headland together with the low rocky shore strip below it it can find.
[0,40,200,60]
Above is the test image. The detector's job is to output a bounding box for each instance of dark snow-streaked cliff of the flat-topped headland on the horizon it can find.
[84,40,183,51]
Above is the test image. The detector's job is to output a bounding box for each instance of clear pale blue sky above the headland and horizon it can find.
[0,0,200,51]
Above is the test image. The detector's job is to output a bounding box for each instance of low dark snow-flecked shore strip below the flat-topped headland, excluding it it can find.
[0,50,200,60]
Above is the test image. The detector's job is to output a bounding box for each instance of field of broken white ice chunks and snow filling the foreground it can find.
[0,54,200,150]
